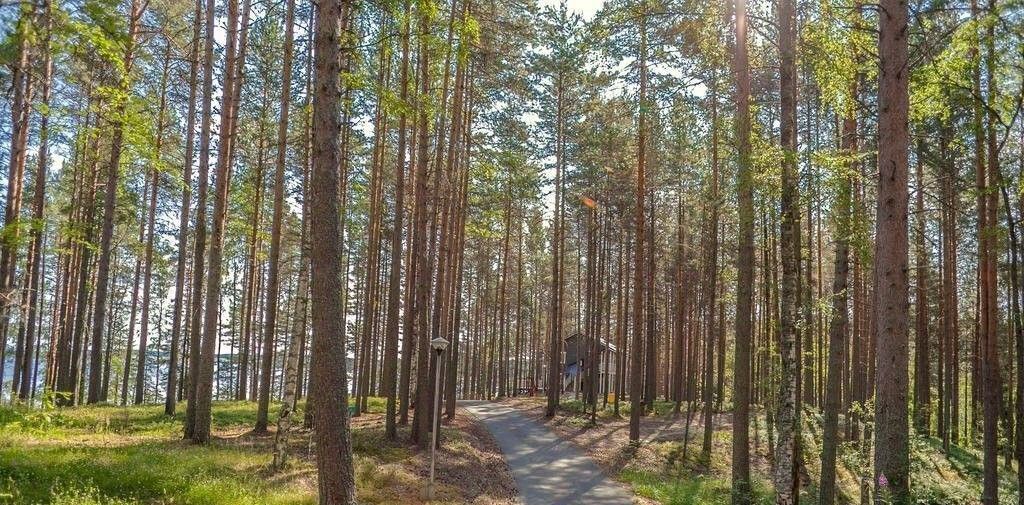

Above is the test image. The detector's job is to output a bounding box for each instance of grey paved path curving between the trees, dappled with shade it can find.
[459,402,633,505]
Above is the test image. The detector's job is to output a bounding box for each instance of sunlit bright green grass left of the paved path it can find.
[0,398,395,499]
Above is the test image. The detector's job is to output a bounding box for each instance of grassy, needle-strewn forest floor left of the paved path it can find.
[0,398,516,505]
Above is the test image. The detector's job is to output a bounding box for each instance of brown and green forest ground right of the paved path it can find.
[504,397,1018,505]
